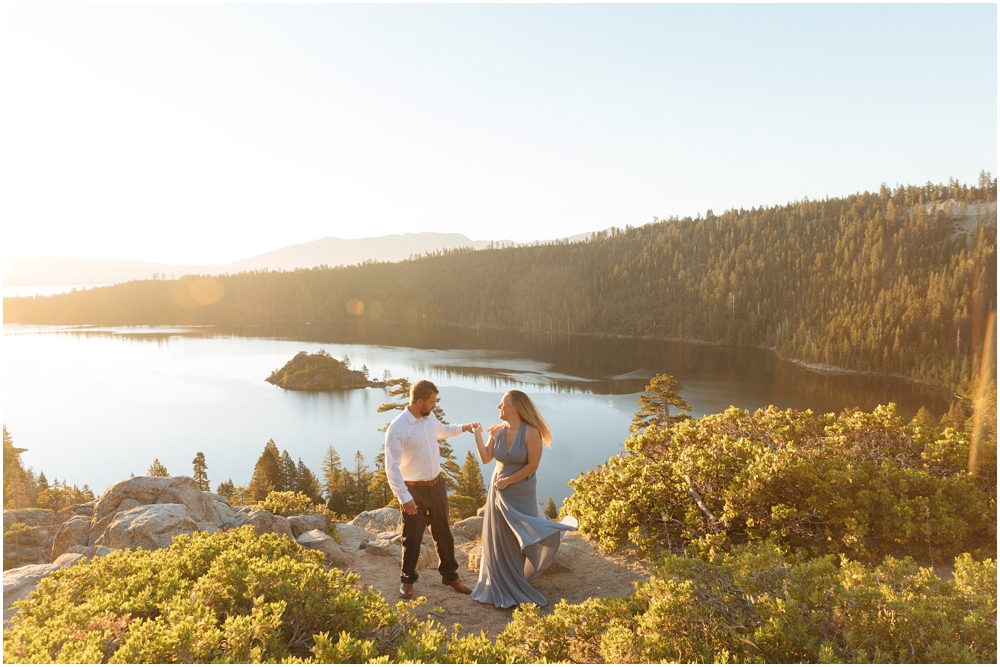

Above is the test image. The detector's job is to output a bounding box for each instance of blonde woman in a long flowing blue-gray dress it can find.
[472,390,575,607]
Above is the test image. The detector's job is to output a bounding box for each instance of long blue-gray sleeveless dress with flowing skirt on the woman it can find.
[472,422,575,607]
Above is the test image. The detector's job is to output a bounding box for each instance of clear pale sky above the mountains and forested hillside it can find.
[0,4,997,263]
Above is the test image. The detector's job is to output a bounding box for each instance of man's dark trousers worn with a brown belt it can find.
[399,478,458,584]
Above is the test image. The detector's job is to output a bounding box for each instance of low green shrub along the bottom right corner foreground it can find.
[497,543,997,663]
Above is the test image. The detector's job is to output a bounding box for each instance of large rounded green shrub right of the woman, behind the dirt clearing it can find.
[564,404,996,563]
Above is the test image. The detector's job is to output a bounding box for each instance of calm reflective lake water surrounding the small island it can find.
[3,323,948,503]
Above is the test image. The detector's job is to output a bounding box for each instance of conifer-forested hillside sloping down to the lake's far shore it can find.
[4,180,997,390]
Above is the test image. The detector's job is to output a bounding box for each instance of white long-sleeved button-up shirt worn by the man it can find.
[385,408,463,505]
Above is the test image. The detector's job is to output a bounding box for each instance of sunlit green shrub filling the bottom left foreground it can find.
[4,526,505,663]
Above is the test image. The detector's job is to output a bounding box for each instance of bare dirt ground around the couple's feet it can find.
[350,532,649,638]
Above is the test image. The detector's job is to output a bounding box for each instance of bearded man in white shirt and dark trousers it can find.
[385,380,477,600]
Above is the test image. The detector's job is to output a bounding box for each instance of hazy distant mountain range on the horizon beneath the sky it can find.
[3,232,590,287]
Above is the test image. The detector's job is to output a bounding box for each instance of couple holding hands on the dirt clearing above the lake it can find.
[385,380,574,607]
